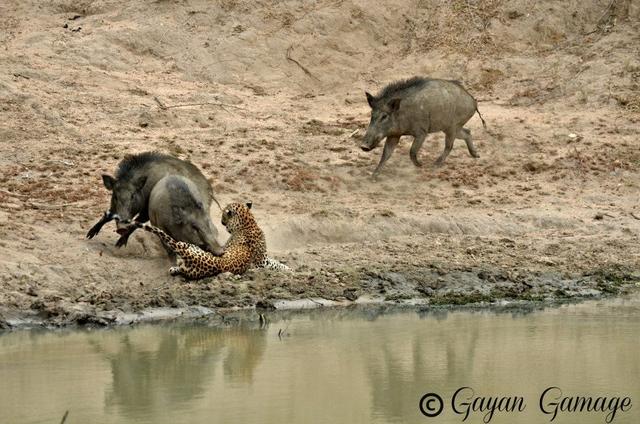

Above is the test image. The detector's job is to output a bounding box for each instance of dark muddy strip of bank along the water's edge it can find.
[0,266,640,330]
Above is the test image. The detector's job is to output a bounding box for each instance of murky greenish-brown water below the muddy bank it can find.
[0,296,640,424]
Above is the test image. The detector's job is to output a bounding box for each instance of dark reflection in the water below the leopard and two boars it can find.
[91,326,266,418]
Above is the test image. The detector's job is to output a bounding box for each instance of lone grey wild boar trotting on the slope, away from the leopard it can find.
[360,77,486,177]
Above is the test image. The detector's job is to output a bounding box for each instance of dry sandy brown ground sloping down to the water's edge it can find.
[0,0,640,324]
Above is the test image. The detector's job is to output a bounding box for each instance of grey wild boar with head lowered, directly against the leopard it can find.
[149,175,223,258]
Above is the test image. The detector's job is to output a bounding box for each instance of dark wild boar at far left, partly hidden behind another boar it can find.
[87,152,220,252]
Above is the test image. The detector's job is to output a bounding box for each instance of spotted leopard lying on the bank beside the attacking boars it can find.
[138,203,290,279]
